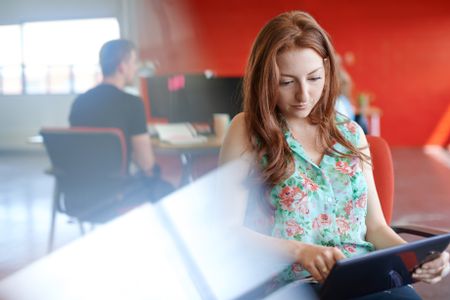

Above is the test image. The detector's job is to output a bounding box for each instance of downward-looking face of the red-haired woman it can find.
[277,48,325,121]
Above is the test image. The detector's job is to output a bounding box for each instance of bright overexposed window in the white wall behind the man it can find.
[0,18,120,94]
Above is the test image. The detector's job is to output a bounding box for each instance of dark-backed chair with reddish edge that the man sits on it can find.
[40,127,134,252]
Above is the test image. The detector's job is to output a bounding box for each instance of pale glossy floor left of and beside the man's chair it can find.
[0,153,79,277]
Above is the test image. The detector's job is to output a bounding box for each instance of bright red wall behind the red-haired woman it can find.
[139,0,450,145]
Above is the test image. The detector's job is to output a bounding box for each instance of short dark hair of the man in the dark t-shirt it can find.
[100,39,136,76]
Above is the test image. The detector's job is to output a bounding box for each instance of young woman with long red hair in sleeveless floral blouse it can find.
[220,11,449,297]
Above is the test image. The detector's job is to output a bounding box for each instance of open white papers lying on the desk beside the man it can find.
[154,123,207,145]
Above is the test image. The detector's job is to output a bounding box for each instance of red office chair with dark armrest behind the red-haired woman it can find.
[367,135,446,237]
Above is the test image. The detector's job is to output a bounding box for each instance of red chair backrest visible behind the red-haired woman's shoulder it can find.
[367,135,394,224]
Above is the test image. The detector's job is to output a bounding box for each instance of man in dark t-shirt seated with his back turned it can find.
[69,39,172,200]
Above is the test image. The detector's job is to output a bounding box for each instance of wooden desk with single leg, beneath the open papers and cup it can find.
[152,136,222,186]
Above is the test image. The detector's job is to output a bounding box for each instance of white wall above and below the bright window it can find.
[0,0,139,150]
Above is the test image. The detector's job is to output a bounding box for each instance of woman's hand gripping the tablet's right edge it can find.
[412,251,450,284]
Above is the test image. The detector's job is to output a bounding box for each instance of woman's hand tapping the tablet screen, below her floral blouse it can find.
[297,244,345,283]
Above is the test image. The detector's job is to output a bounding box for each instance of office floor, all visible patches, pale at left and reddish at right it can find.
[0,148,450,300]
